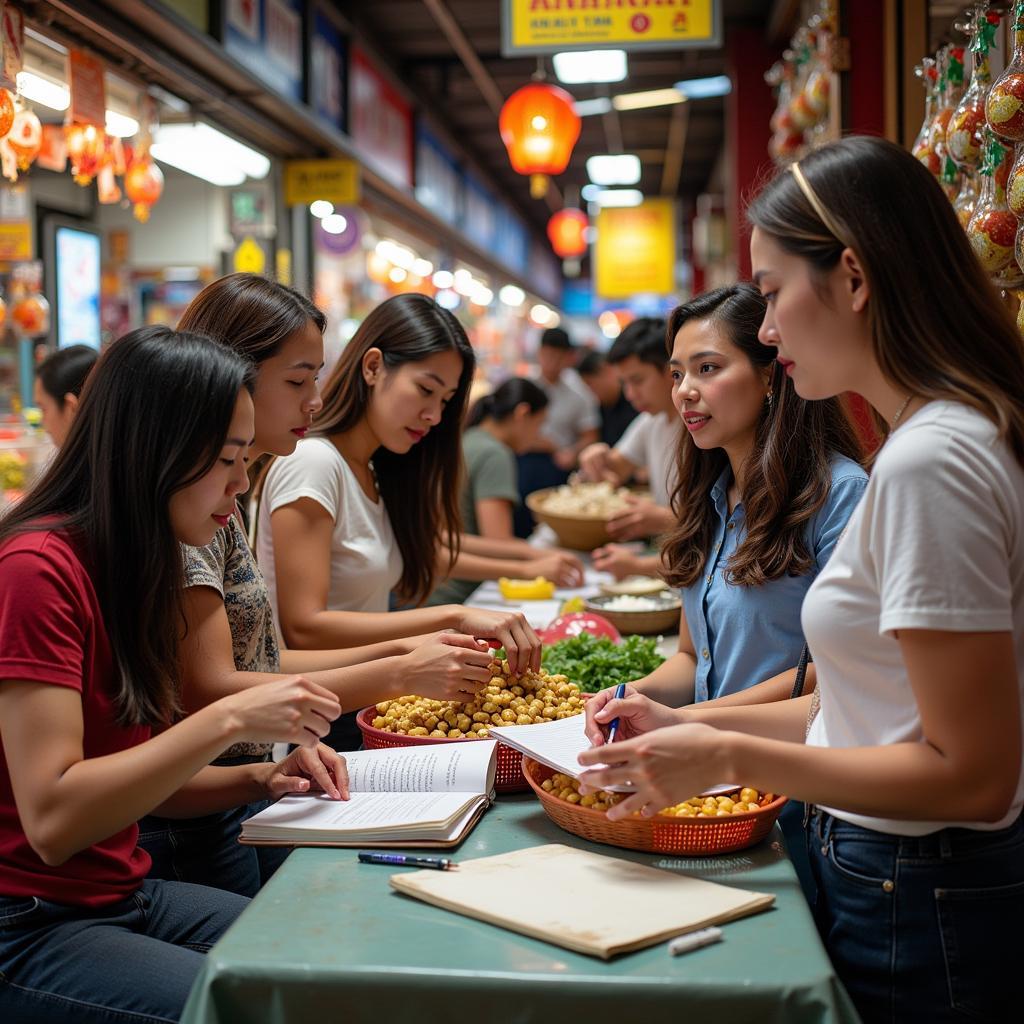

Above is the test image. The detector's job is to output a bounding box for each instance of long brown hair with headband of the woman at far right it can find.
[746,135,1024,465]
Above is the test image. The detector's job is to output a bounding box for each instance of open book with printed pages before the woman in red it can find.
[240,741,498,847]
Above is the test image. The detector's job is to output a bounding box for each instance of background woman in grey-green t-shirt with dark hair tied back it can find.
[427,377,583,604]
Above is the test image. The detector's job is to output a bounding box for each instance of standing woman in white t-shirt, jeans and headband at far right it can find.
[581,137,1024,1024]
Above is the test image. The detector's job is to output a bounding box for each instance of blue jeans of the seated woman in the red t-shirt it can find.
[0,880,249,1024]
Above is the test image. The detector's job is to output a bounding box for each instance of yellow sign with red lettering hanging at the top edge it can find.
[502,0,722,56]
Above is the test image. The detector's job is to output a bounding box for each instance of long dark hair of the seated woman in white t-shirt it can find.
[313,293,476,603]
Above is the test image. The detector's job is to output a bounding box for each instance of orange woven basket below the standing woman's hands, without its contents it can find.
[522,756,786,857]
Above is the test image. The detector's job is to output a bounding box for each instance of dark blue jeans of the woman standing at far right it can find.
[807,808,1024,1024]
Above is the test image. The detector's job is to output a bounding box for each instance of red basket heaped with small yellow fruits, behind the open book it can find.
[355,659,584,793]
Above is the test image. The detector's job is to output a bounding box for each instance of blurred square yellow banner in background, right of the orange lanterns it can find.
[594,199,676,299]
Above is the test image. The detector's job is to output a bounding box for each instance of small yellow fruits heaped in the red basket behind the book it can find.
[373,659,584,741]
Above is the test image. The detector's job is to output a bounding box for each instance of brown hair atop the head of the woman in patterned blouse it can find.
[178,273,327,365]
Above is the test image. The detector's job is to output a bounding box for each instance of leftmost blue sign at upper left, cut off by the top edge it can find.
[222,0,302,101]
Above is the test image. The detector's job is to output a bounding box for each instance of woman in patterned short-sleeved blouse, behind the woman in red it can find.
[140,273,499,896]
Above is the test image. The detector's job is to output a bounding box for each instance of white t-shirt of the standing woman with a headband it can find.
[802,401,1024,836]
